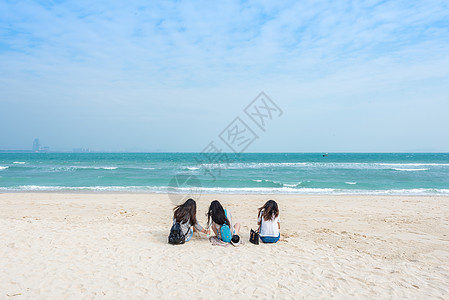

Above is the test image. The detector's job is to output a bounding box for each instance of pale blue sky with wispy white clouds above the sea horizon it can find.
[0,0,449,152]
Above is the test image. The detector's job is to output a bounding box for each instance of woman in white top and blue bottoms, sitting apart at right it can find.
[257,200,281,243]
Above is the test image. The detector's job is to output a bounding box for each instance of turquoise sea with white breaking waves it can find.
[0,153,449,195]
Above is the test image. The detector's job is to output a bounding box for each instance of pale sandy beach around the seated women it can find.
[0,193,449,299]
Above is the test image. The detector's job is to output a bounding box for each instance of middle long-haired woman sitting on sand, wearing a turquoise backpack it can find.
[207,200,240,244]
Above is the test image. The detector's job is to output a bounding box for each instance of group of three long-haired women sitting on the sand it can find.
[169,199,281,246]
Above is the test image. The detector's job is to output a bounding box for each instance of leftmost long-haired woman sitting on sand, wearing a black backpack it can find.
[173,199,209,242]
